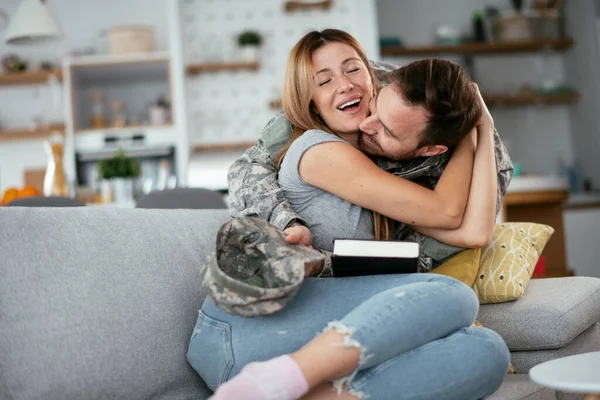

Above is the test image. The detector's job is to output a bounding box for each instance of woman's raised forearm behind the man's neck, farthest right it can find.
[415,86,498,248]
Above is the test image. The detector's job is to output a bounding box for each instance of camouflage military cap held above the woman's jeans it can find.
[202,217,325,317]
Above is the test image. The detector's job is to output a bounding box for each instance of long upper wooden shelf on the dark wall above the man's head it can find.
[381,38,574,56]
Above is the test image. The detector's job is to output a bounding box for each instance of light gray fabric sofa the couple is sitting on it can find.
[0,207,600,400]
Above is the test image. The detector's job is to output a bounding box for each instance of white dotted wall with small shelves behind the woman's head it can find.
[180,0,379,188]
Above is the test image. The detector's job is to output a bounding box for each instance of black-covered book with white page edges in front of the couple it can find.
[331,239,420,277]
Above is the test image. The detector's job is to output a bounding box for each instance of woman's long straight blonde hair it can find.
[275,29,390,240]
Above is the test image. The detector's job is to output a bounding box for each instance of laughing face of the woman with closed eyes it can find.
[312,42,373,135]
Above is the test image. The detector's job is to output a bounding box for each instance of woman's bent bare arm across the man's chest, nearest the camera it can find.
[298,130,475,229]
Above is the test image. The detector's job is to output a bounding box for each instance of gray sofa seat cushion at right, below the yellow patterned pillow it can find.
[477,277,600,350]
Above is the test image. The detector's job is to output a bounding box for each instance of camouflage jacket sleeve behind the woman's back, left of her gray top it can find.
[227,113,308,229]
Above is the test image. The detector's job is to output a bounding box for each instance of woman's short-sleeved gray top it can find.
[279,130,375,251]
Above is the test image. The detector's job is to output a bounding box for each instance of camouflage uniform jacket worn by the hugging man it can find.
[228,62,513,275]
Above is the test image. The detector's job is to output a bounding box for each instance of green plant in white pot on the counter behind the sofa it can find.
[98,149,140,205]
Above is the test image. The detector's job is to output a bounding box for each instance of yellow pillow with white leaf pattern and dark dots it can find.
[473,222,554,304]
